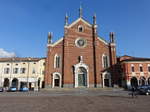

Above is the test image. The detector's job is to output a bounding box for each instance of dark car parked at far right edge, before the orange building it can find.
[137,85,150,95]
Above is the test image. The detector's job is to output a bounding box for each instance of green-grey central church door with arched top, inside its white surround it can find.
[78,67,87,87]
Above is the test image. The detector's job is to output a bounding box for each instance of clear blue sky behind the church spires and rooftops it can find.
[0,0,150,58]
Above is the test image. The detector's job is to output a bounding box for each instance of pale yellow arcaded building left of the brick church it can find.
[0,58,45,90]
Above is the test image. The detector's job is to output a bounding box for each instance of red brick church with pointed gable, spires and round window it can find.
[45,7,117,88]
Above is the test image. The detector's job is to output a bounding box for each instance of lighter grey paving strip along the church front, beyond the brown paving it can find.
[0,88,129,96]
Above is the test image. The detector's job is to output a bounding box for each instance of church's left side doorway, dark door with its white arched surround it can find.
[52,72,62,88]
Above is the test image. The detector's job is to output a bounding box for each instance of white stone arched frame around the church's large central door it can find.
[74,61,89,88]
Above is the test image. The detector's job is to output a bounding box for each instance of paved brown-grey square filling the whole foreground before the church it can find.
[0,89,150,112]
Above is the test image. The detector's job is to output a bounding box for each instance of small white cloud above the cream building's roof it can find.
[0,48,16,58]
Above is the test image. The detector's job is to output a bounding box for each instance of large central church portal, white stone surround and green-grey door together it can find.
[74,61,89,88]
